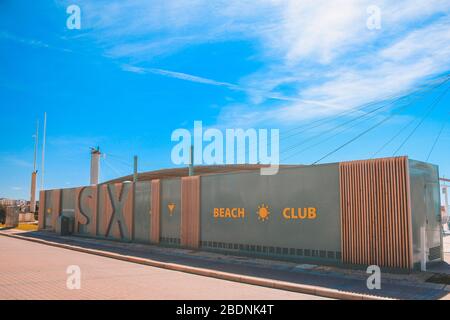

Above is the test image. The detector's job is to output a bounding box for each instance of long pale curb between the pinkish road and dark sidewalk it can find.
[0,232,394,300]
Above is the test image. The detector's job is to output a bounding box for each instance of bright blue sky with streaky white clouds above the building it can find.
[0,0,450,198]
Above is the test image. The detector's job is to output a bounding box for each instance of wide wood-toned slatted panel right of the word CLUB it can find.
[339,157,412,269]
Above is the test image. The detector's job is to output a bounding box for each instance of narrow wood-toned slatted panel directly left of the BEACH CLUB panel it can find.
[180,176,200,249]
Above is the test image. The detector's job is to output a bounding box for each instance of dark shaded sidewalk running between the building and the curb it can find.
[1,230,449,299]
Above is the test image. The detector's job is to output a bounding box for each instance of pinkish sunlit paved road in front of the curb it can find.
[0,236,323,300]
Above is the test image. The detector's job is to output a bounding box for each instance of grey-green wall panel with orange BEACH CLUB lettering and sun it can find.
[200,164,341,263]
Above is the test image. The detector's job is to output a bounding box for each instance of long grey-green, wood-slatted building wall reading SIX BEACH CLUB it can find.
[39,158,437,269]
